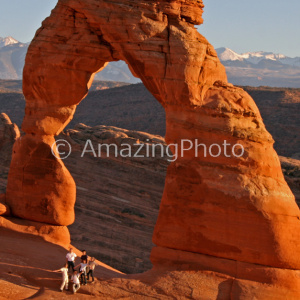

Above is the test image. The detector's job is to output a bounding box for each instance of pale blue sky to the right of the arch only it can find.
[199,0,300,56]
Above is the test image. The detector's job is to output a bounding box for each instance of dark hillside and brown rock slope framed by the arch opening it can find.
[65,59,169,273]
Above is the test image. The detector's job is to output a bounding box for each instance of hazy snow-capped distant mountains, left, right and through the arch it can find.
[0,37,300,88]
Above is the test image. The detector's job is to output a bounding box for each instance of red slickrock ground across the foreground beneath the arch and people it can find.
[0,228,298,300]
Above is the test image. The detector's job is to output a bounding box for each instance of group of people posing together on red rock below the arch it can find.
[54,248,98,294]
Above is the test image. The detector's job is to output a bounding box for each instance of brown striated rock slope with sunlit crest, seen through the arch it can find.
[62,124,168,273]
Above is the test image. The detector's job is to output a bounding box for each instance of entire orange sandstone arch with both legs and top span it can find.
[6,0,300,296]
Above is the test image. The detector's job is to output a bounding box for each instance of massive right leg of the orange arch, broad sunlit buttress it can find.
[153,83,300,269]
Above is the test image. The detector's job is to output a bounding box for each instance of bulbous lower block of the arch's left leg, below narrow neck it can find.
[6,135,76,225]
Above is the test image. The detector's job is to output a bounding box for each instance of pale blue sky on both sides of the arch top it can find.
[0,0,300,56]
